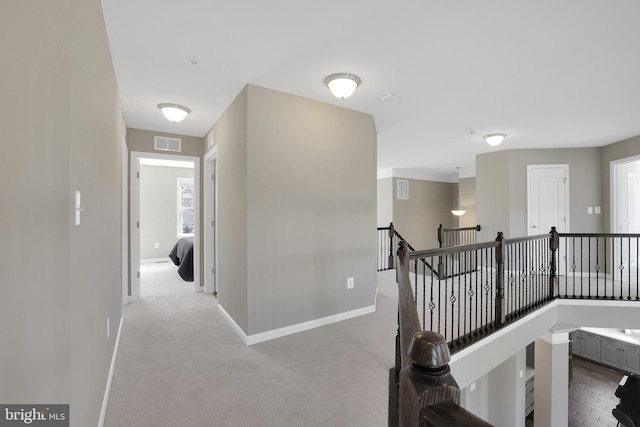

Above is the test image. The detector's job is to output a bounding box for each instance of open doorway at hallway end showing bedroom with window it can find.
[129,152,202,301]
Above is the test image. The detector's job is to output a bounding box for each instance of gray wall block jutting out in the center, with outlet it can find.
[214,85,377,335]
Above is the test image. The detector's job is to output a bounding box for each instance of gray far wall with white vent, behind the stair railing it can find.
[393,178,457,250]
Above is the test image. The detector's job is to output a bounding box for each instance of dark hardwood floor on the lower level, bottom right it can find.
[569,357,624,427]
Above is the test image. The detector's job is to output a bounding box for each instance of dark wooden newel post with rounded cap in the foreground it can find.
[400,331,460,427]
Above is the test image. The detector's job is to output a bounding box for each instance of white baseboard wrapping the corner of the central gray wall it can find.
[218,302,377,345]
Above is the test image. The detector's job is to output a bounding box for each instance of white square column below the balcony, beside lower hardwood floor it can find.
[533,332,569,427]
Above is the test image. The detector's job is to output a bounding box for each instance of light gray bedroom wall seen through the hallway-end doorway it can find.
[140,165,192,259]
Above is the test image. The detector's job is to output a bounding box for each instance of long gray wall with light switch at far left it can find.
[0,0,123,426]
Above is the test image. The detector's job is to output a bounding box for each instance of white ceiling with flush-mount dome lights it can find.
[102,0,640,178]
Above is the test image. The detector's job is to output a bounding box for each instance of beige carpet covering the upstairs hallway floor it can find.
[105,263,397,427]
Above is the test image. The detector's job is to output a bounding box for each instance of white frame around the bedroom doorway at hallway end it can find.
[129,151,202,301]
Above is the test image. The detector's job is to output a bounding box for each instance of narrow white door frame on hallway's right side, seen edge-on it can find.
[202,145,220,294]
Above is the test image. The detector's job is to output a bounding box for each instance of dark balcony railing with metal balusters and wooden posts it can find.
[389,227,640,426]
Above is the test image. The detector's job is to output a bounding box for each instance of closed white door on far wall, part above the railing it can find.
[527,165,569,236]
